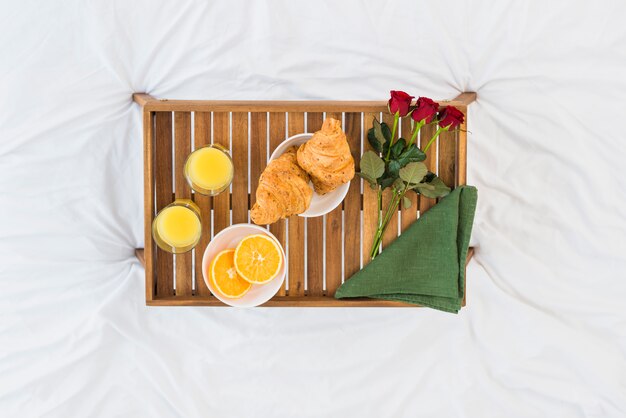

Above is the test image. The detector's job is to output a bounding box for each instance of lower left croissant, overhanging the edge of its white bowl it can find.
[250,146,313,225]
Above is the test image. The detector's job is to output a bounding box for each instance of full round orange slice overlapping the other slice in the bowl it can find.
[235,234,283,284]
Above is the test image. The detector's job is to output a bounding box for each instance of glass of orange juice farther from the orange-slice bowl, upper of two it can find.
[184,144,234,196]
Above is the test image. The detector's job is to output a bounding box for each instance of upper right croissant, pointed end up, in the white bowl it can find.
[298,118,354,195]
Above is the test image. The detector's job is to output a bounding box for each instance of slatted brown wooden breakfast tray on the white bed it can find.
[133,93,476,306]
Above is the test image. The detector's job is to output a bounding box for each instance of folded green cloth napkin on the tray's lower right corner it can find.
[335,186,478,313]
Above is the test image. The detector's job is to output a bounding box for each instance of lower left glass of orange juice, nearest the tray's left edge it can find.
[152,199,202,254]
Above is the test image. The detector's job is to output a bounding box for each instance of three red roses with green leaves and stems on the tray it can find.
[357,90,463,259]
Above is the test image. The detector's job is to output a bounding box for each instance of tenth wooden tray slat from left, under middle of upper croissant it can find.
[325,112,343,296]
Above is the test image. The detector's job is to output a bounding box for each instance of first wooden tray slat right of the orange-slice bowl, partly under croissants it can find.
[287,112,304,296]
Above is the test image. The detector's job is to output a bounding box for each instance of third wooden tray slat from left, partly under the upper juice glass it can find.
[193,112,212,296]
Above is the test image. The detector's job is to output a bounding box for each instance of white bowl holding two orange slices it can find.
[202,224,286,308]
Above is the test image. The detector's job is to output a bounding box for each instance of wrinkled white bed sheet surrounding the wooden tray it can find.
[0,0,626,418]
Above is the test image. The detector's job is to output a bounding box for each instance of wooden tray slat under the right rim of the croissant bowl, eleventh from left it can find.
[343,113,361,278]
